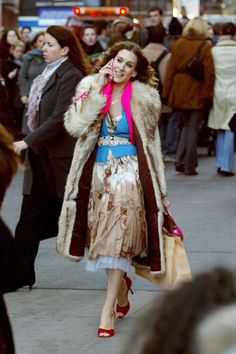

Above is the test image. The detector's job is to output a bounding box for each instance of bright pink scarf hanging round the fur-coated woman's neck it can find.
[101,81,134,143]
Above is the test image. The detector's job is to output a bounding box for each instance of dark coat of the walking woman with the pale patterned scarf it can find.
[23,59,84,197]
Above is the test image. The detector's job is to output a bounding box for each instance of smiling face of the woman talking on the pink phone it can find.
[112,49,138,84]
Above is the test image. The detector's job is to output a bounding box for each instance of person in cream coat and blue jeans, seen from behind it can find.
[208,22,236,177]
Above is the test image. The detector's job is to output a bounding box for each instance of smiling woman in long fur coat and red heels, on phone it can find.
[57,41,168,337]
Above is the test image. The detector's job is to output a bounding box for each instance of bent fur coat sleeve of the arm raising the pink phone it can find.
[64,75,106,138]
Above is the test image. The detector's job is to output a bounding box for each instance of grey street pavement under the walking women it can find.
[2,149,236,354]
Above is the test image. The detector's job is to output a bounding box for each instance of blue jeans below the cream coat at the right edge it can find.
[216,130,234,172]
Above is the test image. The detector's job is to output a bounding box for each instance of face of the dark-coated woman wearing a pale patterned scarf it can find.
[42,33,69,64]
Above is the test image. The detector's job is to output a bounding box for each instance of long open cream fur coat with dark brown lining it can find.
[57,74,167,275]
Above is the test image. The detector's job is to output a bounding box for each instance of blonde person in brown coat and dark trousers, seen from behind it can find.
[163,17,215,176]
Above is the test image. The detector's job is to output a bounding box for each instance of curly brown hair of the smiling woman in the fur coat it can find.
[93,41,156,86]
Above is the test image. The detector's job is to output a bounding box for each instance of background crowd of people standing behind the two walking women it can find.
[0,7,235,176]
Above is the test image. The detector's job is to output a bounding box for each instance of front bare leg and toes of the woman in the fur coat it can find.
[99,269,124,337]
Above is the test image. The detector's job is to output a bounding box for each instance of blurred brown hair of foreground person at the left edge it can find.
[0,124,19,206]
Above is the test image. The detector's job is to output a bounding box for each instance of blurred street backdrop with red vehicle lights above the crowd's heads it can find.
[0,0,236,30]
